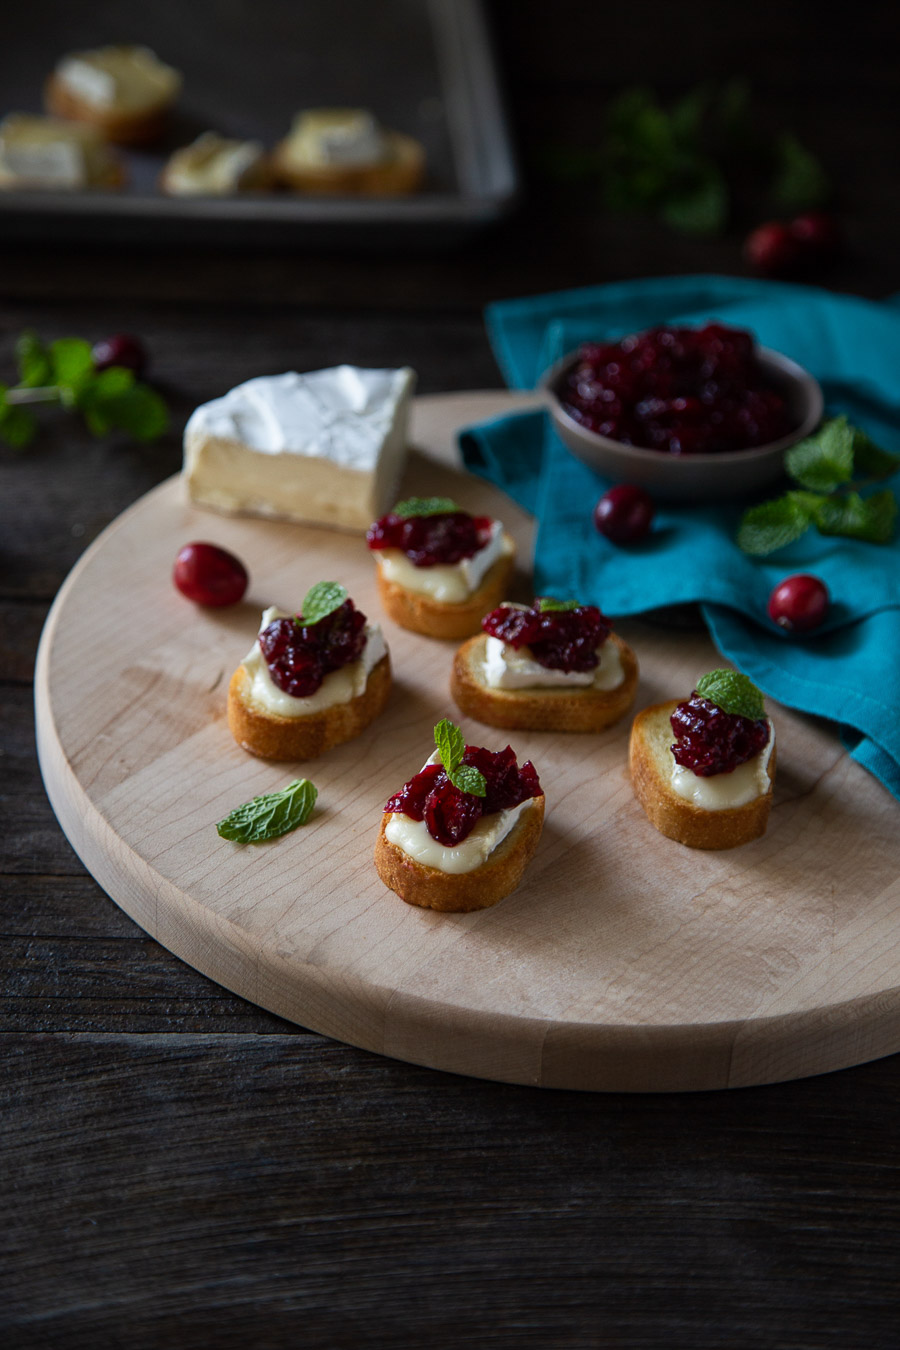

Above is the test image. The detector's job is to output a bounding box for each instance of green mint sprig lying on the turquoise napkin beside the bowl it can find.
[737,416,900,558]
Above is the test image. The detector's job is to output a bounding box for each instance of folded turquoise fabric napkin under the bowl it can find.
[460,277,900,798]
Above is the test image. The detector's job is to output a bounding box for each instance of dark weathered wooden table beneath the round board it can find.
[0,0,900,1350]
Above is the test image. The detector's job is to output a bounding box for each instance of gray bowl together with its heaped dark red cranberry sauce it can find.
[541,323,823,501]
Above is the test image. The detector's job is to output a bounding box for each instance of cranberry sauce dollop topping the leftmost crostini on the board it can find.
[259,599,366,698]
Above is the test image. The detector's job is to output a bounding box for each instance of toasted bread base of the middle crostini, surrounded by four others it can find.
[451,633,638,732]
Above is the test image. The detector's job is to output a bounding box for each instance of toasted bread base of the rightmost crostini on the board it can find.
[629,699,775,849]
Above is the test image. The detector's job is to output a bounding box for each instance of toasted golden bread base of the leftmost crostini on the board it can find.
[228,653,391,760]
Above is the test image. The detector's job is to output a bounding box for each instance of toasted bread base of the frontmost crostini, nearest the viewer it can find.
[375,795,544,914]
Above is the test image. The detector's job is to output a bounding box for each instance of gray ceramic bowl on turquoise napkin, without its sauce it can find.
[540,347,823,502]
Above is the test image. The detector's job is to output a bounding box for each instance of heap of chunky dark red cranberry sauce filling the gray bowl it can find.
[556,324,796,455]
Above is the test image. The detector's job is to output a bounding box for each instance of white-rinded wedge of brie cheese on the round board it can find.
[184,366,416,531]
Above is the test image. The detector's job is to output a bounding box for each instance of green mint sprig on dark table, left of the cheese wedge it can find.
[0,332,169,450]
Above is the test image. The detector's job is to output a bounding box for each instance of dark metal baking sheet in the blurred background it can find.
[0,0,518,246]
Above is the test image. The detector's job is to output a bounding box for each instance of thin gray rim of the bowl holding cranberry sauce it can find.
[537,343,824,468]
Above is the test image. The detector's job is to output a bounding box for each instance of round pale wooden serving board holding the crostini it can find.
[36,393,900,1091]
